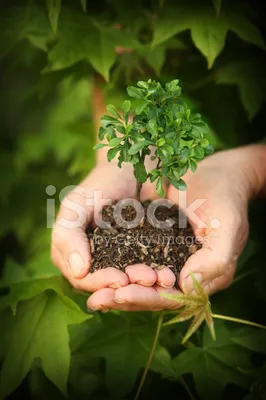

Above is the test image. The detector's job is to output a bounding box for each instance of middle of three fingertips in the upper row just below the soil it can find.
[126,264,157,286]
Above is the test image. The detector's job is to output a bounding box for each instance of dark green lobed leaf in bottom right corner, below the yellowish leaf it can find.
[173,322,266,400]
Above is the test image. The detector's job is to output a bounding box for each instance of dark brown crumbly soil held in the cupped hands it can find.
[87,203,201,281]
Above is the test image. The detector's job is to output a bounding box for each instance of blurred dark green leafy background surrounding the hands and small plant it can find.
[0,0,266,400]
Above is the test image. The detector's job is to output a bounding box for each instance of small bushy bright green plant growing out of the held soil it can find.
[94,79,213,198]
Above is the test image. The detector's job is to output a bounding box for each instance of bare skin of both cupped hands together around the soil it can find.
[52,84,266,311]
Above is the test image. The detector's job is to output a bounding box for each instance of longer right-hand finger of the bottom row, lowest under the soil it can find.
[114,284,183,311]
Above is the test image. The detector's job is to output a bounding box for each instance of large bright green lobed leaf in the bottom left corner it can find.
[0,285,91,398]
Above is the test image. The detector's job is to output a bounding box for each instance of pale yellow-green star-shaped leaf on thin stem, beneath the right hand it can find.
[162,273,215,344]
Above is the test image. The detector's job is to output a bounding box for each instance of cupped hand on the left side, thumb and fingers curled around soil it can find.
[51,162,177,296]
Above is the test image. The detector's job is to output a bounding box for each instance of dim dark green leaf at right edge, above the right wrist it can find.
[216,61,266,119]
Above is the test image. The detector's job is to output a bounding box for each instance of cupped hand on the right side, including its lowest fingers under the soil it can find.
[88,150,251,311]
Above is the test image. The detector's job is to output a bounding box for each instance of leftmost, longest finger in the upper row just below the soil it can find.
[70,267,129,292]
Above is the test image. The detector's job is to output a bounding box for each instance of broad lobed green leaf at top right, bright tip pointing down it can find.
[152,4,265,68]
